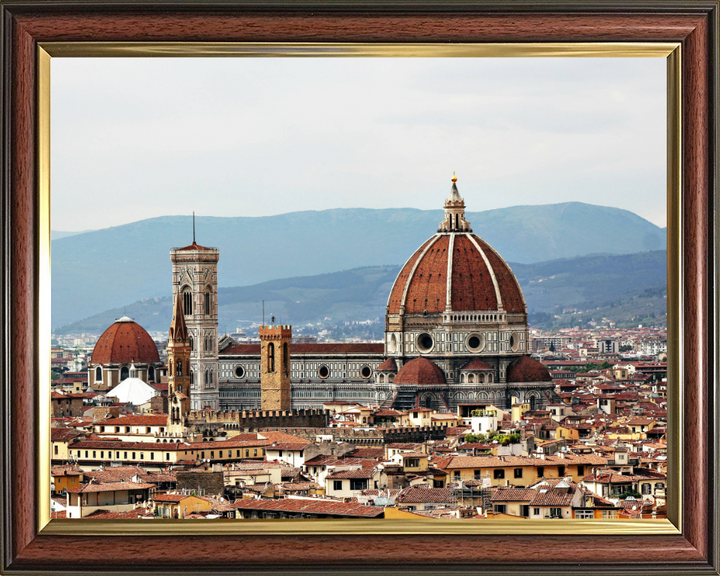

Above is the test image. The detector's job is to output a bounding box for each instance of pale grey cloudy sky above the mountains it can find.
[51,58,666,231]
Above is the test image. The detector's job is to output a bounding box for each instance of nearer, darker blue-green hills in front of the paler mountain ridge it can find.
[55,250,667,334]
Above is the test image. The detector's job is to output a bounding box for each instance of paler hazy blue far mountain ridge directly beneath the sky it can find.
[52,202,666,329]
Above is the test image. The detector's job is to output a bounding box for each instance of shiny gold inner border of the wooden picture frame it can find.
[35,42,683,536]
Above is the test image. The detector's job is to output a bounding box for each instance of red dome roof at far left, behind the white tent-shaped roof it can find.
[90,316,160,364]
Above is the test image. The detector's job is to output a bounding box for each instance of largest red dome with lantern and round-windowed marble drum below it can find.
[385,176,529,360]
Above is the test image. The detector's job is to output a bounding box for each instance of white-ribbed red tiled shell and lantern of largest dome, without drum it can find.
[388,178,527,314]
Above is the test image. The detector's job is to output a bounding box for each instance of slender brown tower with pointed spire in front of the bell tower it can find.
[167,296,191,436]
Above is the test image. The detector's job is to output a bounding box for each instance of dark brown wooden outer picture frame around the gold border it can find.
[0,0,720,574]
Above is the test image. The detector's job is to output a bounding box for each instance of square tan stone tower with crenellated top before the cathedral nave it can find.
[259,326,292,410]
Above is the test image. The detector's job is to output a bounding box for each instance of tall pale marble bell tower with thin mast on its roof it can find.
[170,232,220,410]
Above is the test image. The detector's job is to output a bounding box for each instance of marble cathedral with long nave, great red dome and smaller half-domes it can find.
[218,177,557,411]
